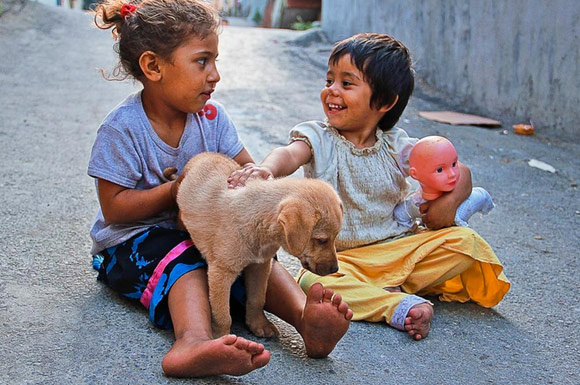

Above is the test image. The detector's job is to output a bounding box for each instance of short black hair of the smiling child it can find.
[328,33,415,131]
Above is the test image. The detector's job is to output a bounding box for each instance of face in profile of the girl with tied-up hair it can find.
[161,33,220,113]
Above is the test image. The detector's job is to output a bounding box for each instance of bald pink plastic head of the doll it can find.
[409,136,459,200]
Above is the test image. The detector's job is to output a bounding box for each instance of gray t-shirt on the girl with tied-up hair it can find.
[88,92,244,255]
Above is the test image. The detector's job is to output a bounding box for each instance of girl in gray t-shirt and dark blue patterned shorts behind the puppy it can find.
[88,0,352,377]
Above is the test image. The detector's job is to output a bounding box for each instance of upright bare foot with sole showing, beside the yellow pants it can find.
[297,283,353,358]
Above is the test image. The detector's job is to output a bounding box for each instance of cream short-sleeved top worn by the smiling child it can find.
[290,121,417,251]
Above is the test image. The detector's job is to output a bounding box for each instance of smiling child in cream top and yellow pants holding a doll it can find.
[230,33,510,340]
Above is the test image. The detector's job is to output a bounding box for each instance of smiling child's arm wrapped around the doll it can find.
[421,162,472,230]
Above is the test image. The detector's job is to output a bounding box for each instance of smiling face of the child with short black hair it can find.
[320,55,388,132]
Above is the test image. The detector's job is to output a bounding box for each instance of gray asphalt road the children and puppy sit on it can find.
[0,3,580,385]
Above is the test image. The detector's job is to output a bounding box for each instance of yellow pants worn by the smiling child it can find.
[297,227,510,328]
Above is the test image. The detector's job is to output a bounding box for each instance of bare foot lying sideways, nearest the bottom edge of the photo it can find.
[161,334,270,377]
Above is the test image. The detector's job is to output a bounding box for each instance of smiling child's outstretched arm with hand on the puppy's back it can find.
[228,140,312,188]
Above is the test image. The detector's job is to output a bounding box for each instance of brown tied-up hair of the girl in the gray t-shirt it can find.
[94,0,221,80]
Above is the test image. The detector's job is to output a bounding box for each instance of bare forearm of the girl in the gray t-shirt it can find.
[98,179,176,223]
